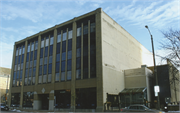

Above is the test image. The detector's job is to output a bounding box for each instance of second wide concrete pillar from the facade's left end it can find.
[19,40,28,108]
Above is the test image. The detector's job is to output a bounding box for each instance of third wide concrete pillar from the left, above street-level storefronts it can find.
[35,33,41,85]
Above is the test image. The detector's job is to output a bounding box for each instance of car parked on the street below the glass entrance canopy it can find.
[121,104,163,113]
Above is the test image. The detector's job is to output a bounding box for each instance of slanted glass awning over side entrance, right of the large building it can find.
[120,87,147,94]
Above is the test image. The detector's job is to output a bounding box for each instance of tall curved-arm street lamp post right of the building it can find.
[145,25,160,109]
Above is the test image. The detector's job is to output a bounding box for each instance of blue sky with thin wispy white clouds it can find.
[0,0,180,68]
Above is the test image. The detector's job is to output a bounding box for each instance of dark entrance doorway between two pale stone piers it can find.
[40,94,49,110]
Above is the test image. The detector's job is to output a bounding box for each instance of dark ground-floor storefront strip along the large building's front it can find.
[10,87,97,111]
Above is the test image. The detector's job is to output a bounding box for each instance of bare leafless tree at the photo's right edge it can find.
[158,29,180,102]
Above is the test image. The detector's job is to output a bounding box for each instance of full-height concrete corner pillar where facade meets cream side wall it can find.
[95,8,104,112]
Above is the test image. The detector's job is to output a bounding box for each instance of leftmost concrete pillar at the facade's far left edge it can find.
[8,45,16,106]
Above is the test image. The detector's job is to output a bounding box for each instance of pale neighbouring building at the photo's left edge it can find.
[0,67,11,103]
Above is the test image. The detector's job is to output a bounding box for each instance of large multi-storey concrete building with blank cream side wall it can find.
[9,8,153,111]
